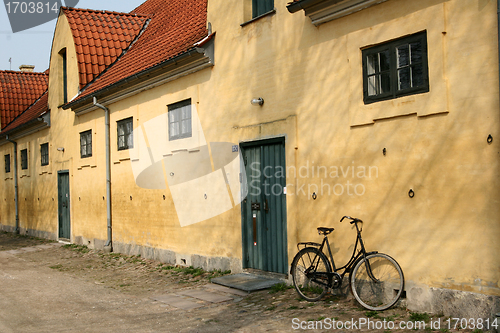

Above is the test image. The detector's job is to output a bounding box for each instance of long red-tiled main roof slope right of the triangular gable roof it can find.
[70,0,208,101]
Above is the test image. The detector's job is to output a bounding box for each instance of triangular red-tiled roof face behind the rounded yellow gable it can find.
[61,7,149,89]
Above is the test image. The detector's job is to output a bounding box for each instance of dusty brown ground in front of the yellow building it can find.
[0,232,480,333]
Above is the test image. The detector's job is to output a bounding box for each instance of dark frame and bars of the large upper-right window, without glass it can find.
[362,31,430,104]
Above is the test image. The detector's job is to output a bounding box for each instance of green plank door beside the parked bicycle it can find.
[241,138,288,274]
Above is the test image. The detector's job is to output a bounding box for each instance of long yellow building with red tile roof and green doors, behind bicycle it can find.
[0,0,500,318]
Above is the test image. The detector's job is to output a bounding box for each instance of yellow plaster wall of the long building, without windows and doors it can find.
[0,0,500,295]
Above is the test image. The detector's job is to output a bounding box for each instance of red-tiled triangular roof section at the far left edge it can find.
[0,71,49,129]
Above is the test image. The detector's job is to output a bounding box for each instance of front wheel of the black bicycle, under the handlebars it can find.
[349,253,404,311]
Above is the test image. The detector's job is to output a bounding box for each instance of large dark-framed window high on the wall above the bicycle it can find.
[362,31,429,104]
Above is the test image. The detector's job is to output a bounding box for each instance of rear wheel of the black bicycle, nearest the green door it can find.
[291,247,331,302]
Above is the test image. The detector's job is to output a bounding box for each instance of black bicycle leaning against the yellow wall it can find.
[290,216,404,311]
